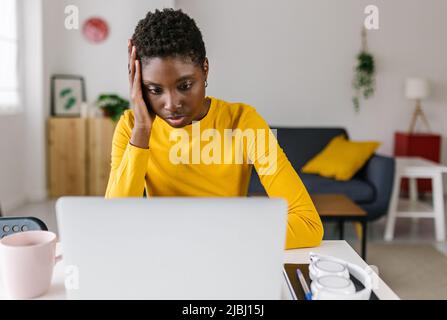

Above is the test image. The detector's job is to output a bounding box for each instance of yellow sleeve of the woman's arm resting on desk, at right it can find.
[244,108,323,249]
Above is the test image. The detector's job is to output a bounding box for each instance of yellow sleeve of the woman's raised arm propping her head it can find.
[105,110,149,199]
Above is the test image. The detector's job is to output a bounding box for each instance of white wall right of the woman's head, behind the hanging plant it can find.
[176,0,447,163]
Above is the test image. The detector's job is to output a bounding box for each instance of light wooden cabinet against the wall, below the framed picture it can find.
[48,118,116,198]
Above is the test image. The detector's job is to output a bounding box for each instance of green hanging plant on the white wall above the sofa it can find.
[352,29,376,112]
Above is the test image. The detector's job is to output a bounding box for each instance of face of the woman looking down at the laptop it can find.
[142,57,209,128]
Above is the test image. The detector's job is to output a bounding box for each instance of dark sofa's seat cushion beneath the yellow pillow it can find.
[299,173,375,202]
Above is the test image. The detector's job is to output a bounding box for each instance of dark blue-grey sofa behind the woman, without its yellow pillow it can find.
[248,127,395,221]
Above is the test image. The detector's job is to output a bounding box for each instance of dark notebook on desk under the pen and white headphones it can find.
[284,263,379,300]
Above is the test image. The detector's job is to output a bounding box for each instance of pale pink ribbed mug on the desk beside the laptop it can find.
[0,231,62,299]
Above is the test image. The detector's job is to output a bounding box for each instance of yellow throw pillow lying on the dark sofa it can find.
[301,135,380,181]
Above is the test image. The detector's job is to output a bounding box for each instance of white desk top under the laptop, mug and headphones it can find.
[0,240,399,300]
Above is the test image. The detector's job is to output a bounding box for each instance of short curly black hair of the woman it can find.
[132,8,206,66]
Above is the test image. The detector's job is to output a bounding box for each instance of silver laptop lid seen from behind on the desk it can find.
[56,197,287,299]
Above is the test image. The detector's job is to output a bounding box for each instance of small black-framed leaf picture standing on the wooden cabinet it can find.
[51,74,86,117]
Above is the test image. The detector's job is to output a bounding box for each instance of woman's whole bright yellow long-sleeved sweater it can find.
[105,97,323,249]
